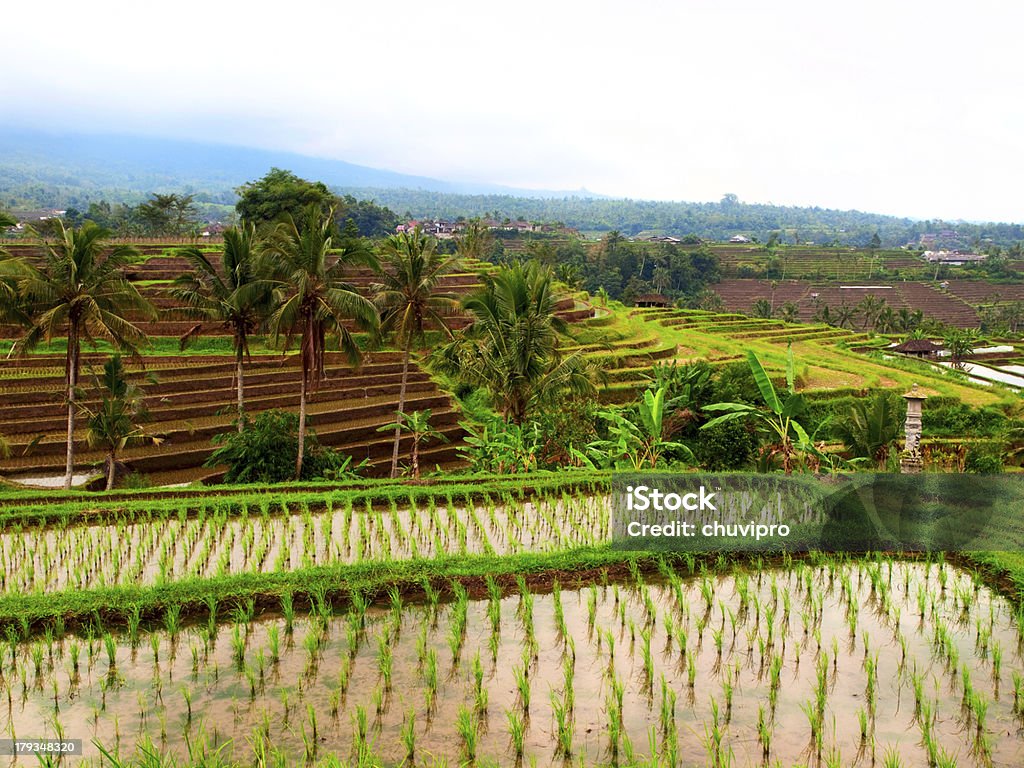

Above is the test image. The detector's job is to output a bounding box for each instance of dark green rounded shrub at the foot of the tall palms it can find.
[206,411,358,482]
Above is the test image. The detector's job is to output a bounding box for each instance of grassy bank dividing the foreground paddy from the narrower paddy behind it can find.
[0,545,1024,637]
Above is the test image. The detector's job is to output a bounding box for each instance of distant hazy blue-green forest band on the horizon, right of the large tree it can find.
[341,187,1024,248]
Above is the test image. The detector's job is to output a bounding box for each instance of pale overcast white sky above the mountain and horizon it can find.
[0,0,1024,221]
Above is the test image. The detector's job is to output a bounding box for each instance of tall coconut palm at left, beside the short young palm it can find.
[3,220,156,488]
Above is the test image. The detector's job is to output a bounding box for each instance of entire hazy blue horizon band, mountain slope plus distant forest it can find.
[0,129,1024,248]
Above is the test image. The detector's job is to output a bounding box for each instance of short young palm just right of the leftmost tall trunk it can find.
[82,354,162,490]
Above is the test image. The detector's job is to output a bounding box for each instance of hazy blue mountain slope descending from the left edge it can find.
[0,129,593,207]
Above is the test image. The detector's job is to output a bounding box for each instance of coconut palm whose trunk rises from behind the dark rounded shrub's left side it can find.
[168,222,274,432]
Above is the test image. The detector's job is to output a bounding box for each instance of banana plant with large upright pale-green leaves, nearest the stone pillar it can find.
[700,345,826,474]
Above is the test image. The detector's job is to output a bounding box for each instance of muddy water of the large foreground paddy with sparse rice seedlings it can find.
[0,562,1024,768]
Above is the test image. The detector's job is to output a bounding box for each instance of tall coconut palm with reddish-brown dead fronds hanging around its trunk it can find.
[264,206,380,479]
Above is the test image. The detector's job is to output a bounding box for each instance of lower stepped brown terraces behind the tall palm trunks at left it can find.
[0,352,463,484]
